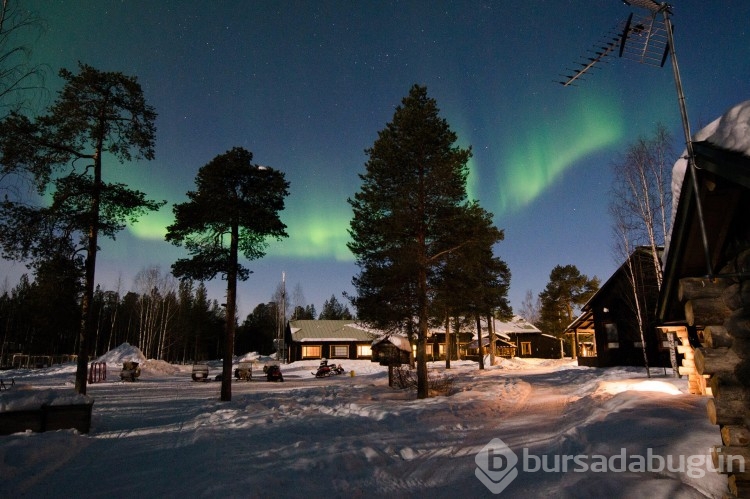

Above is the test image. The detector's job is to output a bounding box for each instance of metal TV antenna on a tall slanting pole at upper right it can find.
[558,0,714,279]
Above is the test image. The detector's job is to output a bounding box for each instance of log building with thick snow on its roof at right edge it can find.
[657,101,750,497]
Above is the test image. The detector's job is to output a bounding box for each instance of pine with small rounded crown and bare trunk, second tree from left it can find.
[166,147,289,401]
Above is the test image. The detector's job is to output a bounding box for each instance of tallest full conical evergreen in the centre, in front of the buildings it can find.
[348,85,471,398]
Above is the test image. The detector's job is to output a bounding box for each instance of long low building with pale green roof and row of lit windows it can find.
[285,320,381,362]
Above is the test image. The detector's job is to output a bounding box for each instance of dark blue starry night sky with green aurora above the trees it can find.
[2,0,750,319]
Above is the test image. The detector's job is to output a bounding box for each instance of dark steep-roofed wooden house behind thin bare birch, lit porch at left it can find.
[565,247,671,367]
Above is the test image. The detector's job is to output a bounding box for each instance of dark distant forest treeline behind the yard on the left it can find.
[0,266,352,366]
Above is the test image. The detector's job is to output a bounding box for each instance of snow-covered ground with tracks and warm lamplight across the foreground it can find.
[0,347,726,498]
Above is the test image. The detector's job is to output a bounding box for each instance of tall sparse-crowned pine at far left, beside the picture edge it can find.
[0,64,163,393]
